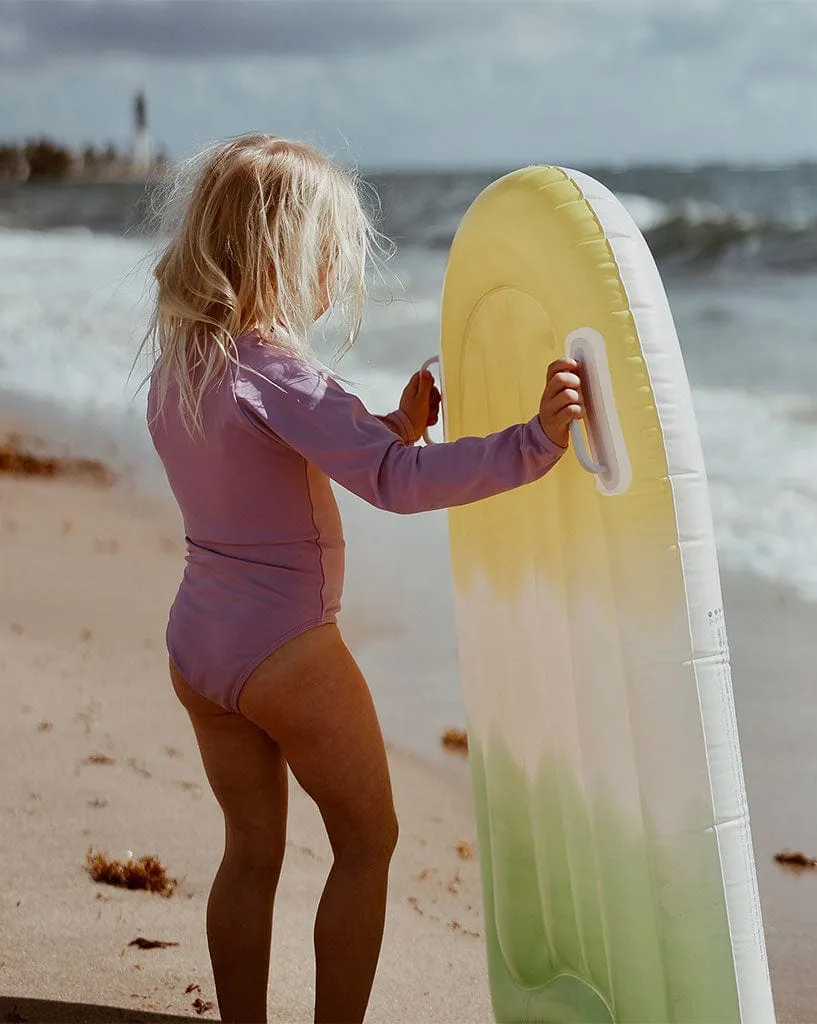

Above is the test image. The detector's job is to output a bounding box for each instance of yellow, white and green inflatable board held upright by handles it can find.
[441,167,774,1024]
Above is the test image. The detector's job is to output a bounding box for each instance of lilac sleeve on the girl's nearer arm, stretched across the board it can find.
[234,352,565,514]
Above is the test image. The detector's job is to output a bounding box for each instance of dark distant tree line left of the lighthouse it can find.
[0,137,167,182]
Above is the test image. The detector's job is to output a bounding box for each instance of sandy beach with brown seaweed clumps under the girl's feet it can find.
[0,458,817,1024]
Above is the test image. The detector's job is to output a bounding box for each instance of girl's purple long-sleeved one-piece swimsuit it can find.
[148,335,563,711]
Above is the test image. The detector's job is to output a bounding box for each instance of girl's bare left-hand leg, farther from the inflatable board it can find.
[170,664,287,1024]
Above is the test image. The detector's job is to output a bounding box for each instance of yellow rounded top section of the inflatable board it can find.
[441,167,684,625]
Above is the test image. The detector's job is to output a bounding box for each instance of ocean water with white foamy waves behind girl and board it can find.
[0,168,817,754]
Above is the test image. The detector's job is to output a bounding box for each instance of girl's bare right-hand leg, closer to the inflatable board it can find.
[240,626,397,1024]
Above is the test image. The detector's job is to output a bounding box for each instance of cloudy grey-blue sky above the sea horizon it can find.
[0,0,817,168]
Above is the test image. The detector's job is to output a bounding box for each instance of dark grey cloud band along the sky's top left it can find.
[0,0,482,61]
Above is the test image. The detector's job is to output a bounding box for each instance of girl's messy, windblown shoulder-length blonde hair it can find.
[145,133,384,432]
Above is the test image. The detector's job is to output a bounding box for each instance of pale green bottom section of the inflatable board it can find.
[470,741,740,1024]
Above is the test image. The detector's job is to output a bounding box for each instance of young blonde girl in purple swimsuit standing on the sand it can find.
[148,134,582,1024]
